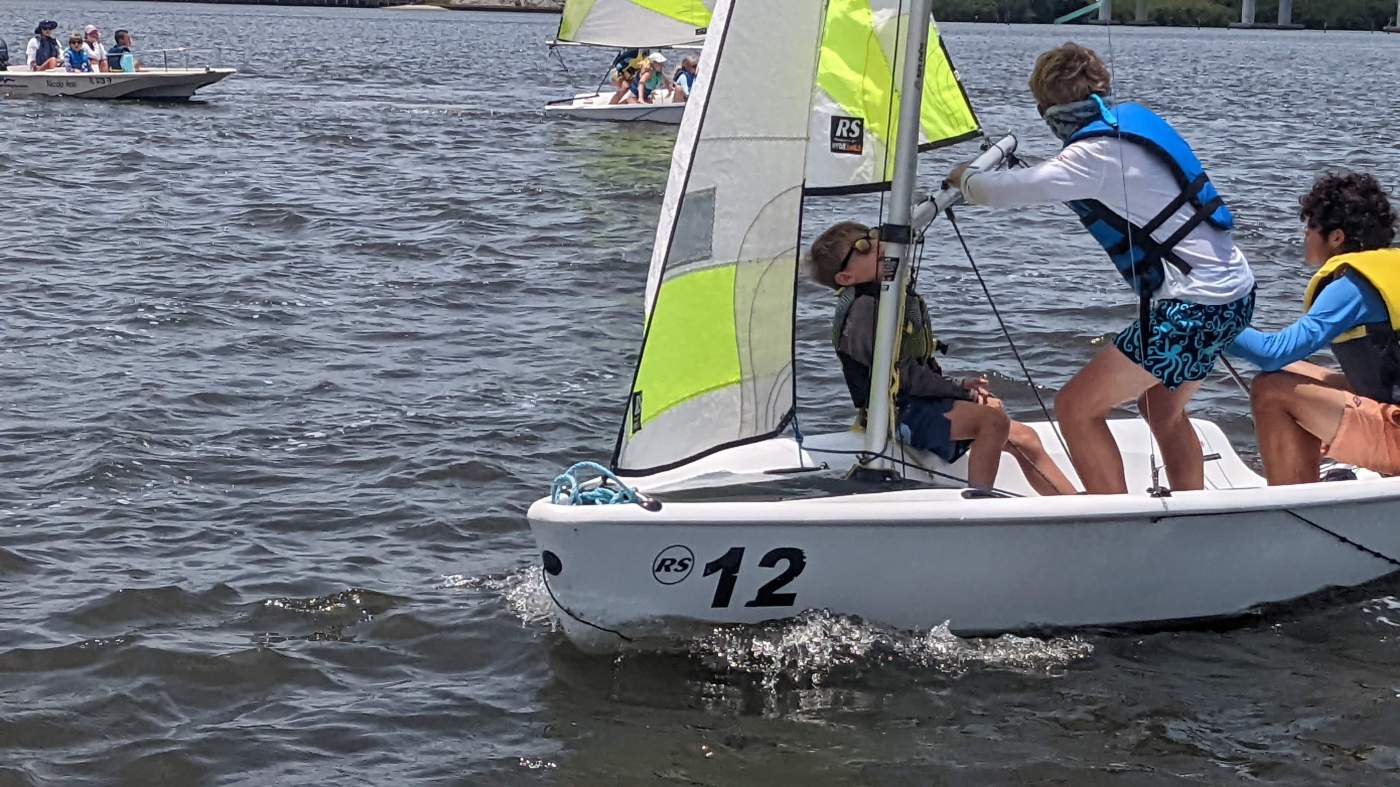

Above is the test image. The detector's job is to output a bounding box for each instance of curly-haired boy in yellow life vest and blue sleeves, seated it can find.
[1229,174,1400,485]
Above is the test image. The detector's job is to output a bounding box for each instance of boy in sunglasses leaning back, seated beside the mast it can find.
[808,221,1074,494]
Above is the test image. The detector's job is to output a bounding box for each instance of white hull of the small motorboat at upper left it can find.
[0,69,234,101]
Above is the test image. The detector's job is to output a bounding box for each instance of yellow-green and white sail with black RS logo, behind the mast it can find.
[806,0,981,193]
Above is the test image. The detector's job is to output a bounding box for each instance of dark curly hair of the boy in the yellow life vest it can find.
[1298,172,1396,252]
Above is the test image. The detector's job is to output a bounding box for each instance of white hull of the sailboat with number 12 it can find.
[529,423,1400,651]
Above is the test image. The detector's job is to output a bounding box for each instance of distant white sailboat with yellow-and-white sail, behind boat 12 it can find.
[545,0,714,125]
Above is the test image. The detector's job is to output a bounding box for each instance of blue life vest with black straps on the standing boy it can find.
[1067,102,1235,298]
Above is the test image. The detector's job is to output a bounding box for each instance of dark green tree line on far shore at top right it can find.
[935,0,1396,29]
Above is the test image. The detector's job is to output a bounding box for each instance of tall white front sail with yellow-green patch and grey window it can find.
[613,0,823,473]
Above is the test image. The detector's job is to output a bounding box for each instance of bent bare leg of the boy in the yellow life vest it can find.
[1249,364,1350,486]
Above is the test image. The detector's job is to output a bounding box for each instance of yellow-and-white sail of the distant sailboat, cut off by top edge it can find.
[556,0,714,49]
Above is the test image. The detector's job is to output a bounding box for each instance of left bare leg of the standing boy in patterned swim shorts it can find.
[1054,344,1158,494]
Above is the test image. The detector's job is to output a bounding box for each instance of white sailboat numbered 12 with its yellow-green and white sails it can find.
[528,0,1400,650]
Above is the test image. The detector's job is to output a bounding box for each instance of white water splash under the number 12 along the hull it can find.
[690,611,1093,689]
